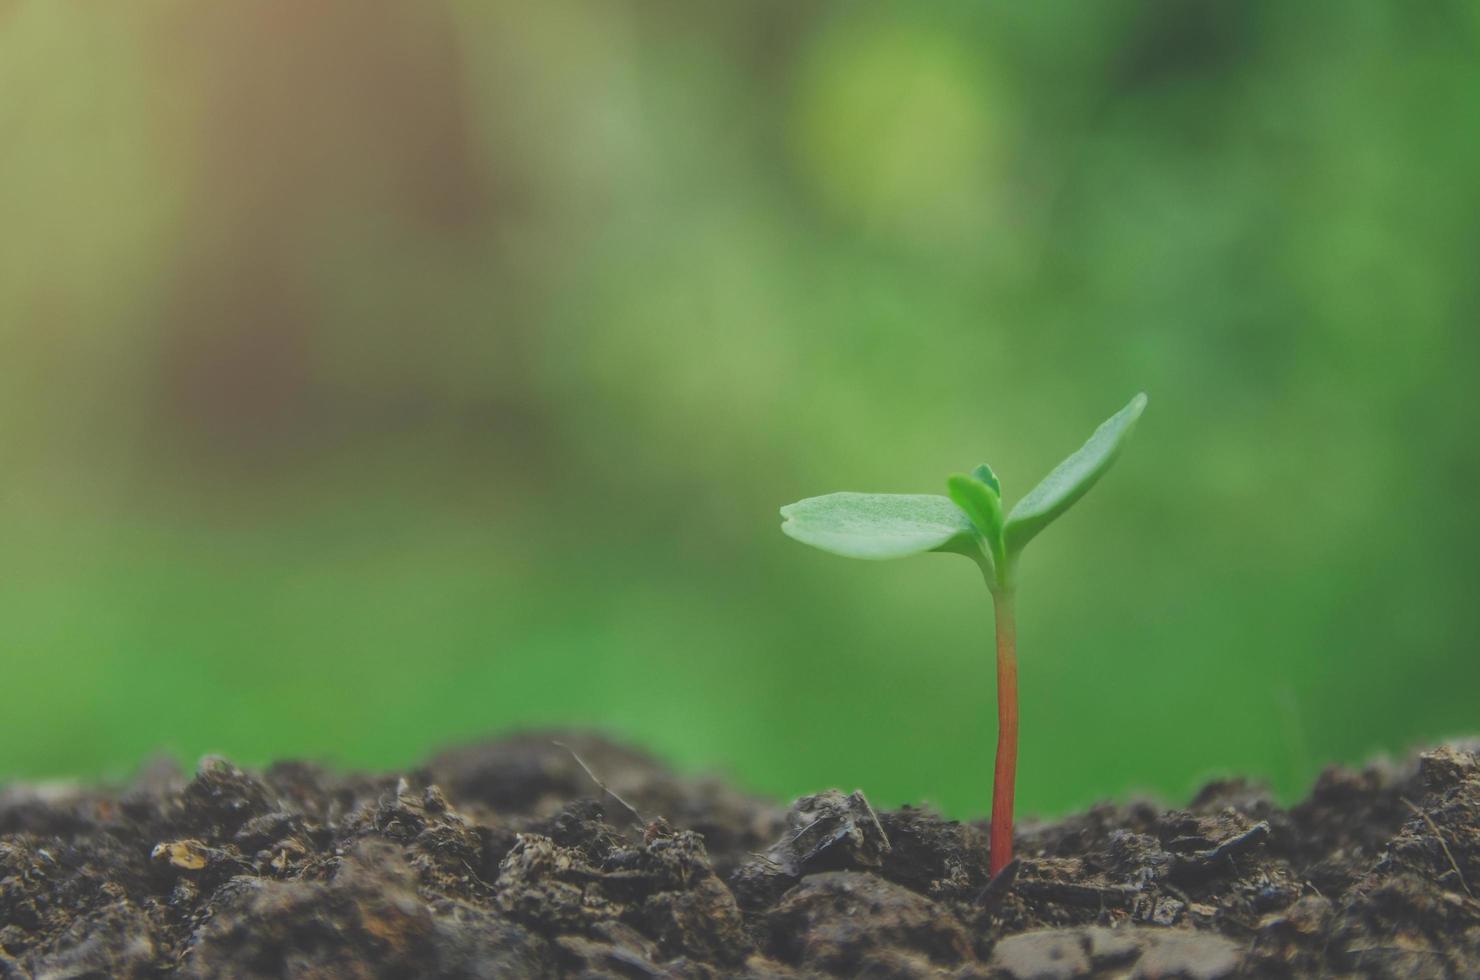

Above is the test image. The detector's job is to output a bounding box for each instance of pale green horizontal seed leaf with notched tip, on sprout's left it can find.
[781,493,977,561]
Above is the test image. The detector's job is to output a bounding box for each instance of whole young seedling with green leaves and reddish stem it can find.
[781,394,1146,875]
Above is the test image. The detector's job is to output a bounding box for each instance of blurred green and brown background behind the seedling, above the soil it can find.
[0,0,1480,814]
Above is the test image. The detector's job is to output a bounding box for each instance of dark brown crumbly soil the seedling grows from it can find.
[0,734,1480,980]
